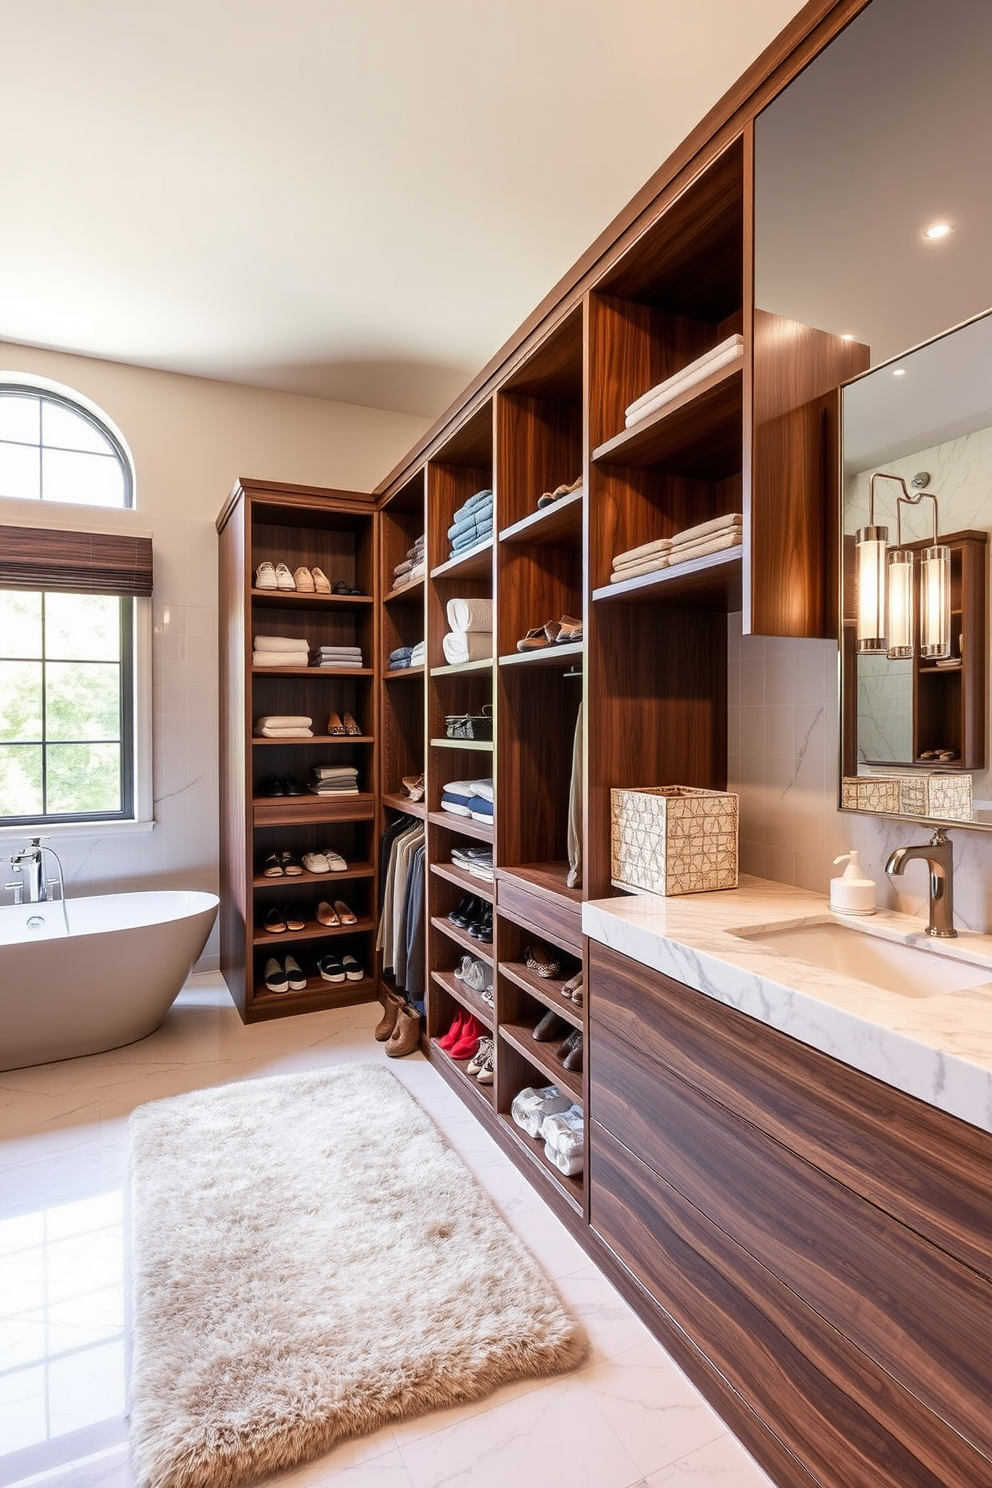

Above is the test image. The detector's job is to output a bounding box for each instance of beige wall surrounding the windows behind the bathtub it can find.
[0,342,427,967]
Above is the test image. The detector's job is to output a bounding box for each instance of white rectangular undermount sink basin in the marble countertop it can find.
[730,918,992,997]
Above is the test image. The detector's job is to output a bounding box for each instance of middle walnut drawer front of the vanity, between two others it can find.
[590,1034,992,1457]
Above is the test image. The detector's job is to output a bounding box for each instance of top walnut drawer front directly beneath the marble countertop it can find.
[589,942,992,1280]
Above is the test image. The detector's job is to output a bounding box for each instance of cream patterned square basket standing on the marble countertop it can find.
[610,786,738,896]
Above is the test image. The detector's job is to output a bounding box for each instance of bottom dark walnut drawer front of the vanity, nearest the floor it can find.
[589,1120,992,1488]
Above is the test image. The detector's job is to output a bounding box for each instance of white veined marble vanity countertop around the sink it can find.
[582,875,992,1131]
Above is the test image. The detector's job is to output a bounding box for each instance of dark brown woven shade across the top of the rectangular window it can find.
[0,525,152,595]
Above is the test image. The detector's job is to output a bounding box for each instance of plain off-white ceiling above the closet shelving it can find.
[0,0,800,417]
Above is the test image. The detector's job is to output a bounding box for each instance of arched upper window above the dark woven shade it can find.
[0,373,134,506]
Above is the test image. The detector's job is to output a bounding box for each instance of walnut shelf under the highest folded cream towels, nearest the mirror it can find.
[592,362,744,481]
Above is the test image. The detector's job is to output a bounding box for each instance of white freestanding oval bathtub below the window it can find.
[0,890,217,1070]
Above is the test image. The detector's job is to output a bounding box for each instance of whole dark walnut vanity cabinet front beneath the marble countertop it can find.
[589,943,992,1488]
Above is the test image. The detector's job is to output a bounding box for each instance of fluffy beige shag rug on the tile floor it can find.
[131,1064,586,1488]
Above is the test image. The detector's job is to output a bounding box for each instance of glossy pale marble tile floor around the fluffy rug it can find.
[0,975,769,1488]
